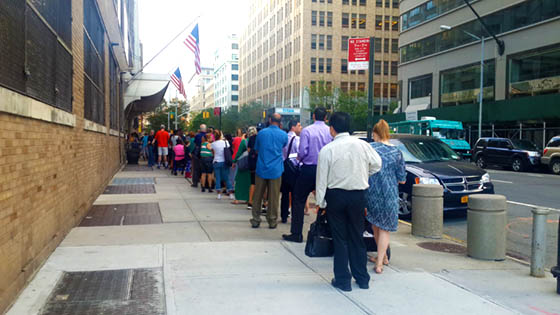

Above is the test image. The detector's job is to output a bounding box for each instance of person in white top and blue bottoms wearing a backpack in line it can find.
[212,130,235,200]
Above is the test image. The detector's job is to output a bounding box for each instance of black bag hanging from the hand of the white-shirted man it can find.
[305,211,334,257]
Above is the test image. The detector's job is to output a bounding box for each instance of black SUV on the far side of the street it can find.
[472,138,541,172]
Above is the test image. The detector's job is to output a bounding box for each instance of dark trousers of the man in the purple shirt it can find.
[290,165,317,235]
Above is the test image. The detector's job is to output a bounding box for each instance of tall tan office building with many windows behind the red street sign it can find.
[240,0,399,115]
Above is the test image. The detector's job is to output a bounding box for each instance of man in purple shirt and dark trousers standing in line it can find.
[282,107,332,243]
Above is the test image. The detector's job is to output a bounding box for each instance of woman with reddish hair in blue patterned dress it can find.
[366,119,406,273]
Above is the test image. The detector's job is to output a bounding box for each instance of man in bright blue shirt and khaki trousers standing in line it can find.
[250,113,288,229]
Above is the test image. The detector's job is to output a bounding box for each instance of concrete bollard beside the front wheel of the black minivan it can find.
[412,184,443,238]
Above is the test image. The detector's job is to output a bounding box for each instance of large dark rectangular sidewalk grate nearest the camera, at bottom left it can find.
[41,269,165,315]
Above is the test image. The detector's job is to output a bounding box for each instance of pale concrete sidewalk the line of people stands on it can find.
[8,167,560,315]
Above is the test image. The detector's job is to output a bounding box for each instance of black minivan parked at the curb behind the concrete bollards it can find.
[384,134,494,216]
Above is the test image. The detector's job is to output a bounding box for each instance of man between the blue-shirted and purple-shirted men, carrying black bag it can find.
[280,119,301,223]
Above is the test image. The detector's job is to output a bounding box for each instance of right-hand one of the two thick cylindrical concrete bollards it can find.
[467,194,507,260]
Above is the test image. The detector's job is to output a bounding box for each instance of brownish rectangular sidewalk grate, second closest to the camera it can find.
[80,203,163,226]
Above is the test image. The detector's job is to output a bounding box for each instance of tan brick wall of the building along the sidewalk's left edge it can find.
[0,0,124,313]
